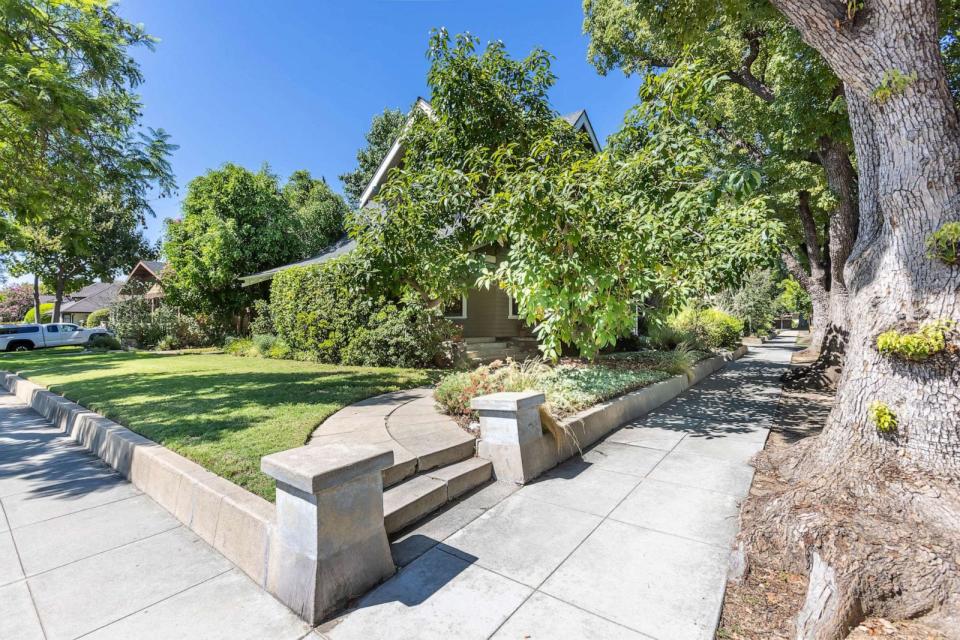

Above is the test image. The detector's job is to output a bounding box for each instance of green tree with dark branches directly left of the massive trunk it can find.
[584,0,858,371]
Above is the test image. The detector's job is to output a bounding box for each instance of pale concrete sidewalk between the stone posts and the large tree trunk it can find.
[315,337,794,640]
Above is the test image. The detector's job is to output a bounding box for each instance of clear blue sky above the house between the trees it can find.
[120,0,639,245]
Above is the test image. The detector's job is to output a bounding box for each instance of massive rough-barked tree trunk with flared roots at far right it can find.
[744,0,960,639]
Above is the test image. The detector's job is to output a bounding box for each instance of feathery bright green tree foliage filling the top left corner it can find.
[0,0,174,227]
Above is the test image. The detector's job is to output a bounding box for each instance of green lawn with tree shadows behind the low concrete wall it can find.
[0,347,436,501]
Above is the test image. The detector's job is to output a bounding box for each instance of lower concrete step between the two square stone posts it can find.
[383,458,493,534]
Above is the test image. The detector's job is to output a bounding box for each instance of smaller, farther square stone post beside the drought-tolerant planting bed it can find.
[470,391,555,484]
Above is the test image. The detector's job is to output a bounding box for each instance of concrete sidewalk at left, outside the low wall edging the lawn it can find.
[0,391,310,640]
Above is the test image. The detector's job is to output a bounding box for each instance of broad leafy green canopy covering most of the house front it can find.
[350,31,780,357]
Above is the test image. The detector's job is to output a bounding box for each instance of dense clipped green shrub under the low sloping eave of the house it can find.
[270,256,383,364]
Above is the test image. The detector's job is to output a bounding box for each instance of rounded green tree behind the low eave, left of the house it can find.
[163,163,302,325]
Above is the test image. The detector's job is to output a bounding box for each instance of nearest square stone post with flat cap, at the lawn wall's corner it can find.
[260,444,394,624]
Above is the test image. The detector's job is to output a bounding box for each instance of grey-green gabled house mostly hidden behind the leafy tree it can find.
[240,98,600,343]
